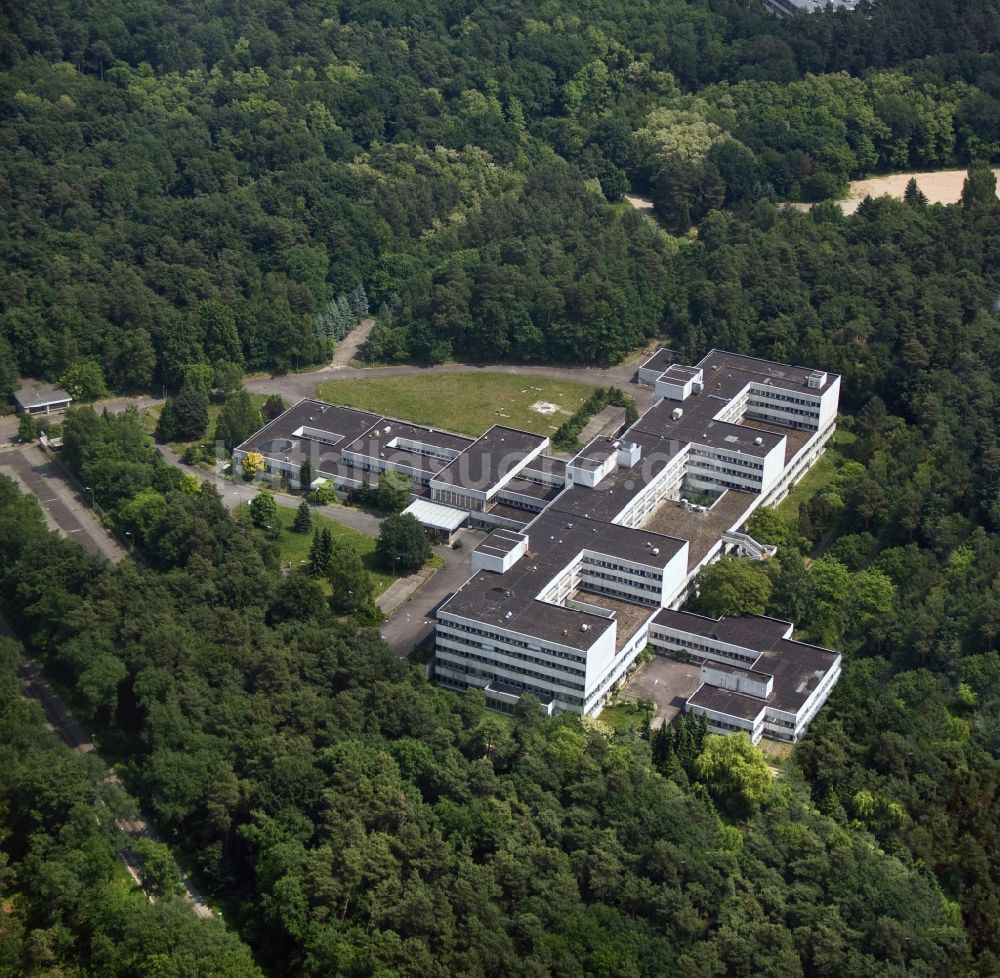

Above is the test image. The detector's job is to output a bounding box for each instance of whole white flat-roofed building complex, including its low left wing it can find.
[233,349,840,741]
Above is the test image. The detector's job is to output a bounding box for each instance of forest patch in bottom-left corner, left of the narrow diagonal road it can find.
[0,628,261,978]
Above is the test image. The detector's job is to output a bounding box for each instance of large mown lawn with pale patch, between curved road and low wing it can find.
[316,372,594,436]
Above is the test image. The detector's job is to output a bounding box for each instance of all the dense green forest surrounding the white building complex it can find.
[0,0,1000,978]
